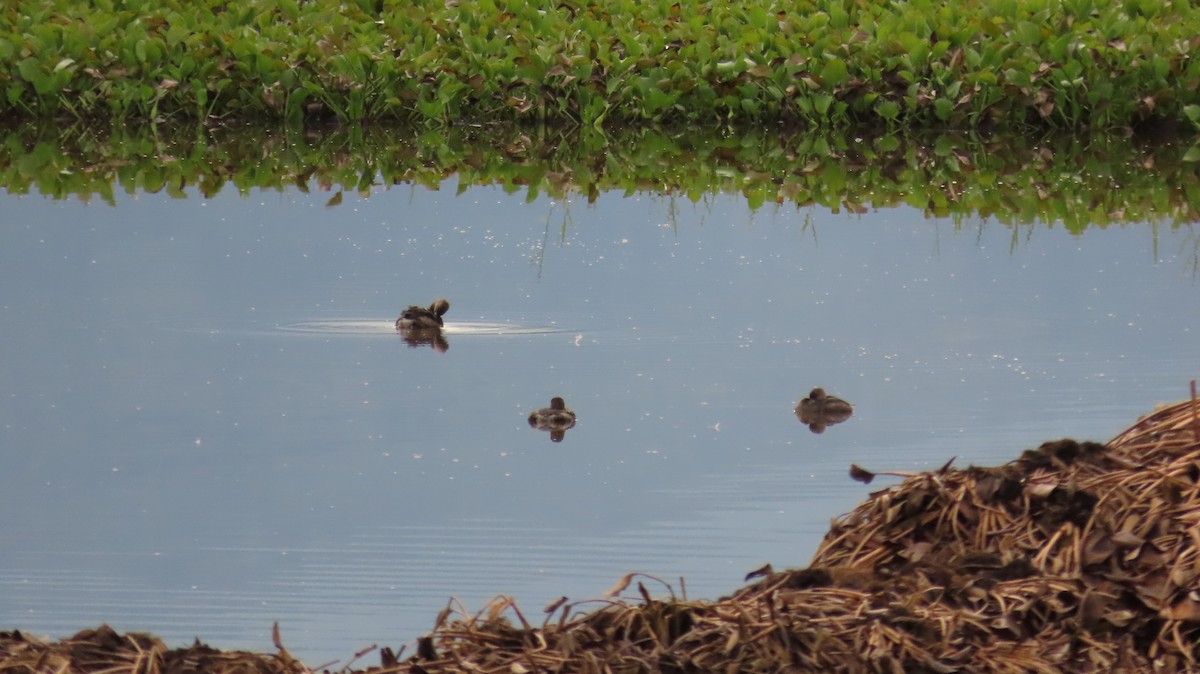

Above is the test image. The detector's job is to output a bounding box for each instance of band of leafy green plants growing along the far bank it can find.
[7,0,1200,128]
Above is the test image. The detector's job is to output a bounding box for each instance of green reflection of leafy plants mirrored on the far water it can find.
[7,126,1200,230]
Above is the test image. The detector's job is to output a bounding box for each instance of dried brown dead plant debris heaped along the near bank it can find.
[7,393,1200,674]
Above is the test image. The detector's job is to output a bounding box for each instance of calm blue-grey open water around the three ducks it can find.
[0,179,1200,664]
